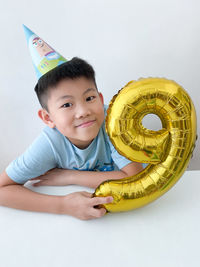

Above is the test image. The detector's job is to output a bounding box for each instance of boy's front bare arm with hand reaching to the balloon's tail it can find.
[0,171,113,220]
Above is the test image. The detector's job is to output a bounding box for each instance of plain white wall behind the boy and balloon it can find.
[0,0,200,171]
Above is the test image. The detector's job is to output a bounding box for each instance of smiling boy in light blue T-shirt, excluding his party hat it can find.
[0,28,142,220]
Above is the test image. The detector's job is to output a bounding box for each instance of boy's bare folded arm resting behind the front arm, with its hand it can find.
[33,162,143,188]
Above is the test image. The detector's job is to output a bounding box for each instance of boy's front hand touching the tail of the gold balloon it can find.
[61,192,113,220]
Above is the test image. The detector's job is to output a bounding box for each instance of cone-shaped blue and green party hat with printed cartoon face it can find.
[23,25,67,79]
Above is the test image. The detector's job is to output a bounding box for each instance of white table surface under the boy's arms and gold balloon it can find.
[0,171,200,267]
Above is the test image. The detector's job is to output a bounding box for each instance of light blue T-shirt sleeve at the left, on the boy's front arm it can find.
[6,133,57,184]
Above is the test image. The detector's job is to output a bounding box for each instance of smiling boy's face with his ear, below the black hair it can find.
[39,77,104,149]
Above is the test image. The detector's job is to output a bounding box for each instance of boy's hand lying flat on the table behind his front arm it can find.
[31,168,74,187]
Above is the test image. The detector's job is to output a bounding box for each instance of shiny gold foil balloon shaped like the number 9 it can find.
[94,78,196,212]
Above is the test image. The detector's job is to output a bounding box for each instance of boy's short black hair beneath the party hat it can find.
[35,57,97,111]
